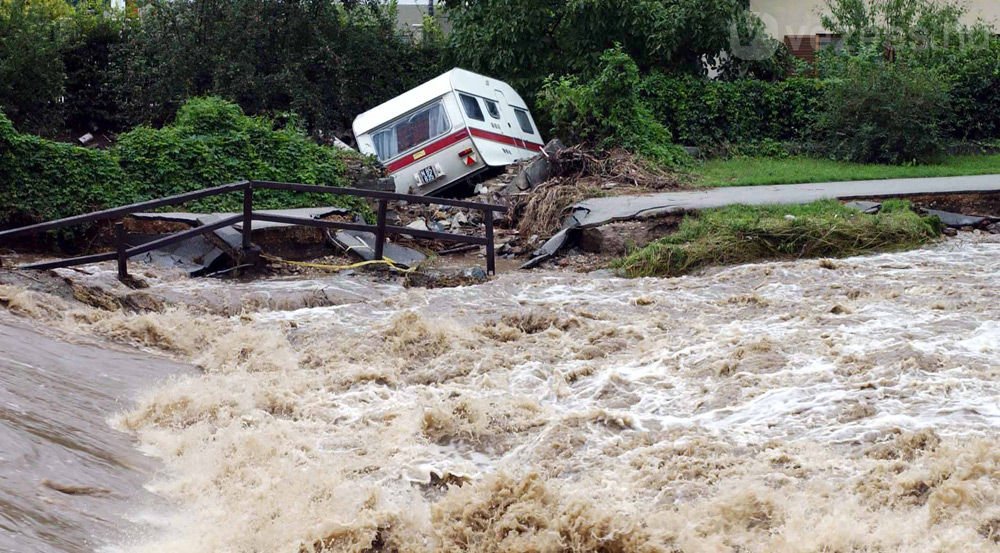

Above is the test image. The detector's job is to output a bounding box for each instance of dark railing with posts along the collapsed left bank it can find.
[0,181,507,279]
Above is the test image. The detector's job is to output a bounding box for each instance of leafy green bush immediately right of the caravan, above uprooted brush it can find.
[538,48,686,166]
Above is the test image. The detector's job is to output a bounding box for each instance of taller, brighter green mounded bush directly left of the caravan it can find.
[112,98,376,211]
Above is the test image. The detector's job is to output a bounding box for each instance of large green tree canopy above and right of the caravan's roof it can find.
[446,0,747,96]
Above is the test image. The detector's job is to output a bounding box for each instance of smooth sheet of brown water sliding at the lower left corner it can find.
[0,311,191,553]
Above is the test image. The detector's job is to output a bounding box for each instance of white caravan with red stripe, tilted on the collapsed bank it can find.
[354,69,543,195]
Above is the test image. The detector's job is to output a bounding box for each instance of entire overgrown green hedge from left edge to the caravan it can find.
[0,98,373,227]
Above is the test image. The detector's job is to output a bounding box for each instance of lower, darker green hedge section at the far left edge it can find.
[0,112,137,225]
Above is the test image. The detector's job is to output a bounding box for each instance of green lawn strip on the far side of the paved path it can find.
[694,154,1000,186]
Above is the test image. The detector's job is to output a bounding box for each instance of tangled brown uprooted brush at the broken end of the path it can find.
[514,146,687,236]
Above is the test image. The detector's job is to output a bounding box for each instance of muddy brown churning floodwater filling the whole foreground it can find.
[0,236,1000,553]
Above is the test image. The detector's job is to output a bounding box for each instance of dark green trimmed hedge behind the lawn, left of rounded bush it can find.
[641,73,825,146]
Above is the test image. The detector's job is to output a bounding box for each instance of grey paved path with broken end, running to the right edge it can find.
[573,171,1000,228]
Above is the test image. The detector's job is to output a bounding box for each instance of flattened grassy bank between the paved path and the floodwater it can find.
[614,200,941,277]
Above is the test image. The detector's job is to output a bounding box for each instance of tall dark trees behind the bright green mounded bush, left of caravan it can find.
[110,0,439,138]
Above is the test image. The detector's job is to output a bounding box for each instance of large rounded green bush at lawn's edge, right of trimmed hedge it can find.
[817,58,950,164]
